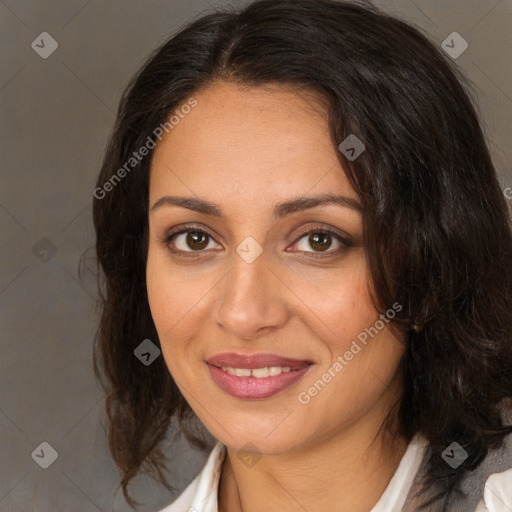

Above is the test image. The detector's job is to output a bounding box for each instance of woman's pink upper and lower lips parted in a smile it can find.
[207,353,312,400]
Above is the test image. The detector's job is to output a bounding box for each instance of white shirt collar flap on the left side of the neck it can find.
[160,442,226,512]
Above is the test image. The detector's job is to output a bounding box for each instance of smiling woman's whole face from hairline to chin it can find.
[146,83,404,454]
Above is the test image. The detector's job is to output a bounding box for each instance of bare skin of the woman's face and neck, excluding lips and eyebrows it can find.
[147,82,407,512]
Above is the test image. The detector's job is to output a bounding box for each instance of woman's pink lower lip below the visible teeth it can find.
[208,364,311,400]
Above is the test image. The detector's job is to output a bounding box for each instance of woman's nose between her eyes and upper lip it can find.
[214,245,290,341]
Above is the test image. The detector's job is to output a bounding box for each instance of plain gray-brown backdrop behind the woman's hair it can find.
[0,0,512,512]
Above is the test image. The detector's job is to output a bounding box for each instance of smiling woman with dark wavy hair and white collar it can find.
[94,0,512,512]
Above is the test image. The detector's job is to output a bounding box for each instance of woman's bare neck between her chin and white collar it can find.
[218,416,407,512]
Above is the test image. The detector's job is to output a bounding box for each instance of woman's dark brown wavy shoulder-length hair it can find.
[87,0,512,510]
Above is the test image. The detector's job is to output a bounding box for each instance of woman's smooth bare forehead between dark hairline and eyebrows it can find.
[150,82,356,202]
